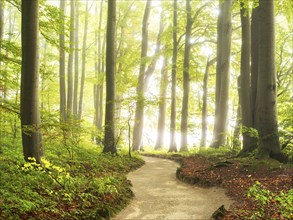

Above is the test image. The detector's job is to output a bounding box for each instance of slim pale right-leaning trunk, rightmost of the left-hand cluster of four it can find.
[78,0,88,120]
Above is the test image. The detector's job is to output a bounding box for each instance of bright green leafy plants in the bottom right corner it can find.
[247,182,293,219]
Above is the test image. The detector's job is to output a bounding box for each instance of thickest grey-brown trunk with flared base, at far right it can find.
[256,0,281,159]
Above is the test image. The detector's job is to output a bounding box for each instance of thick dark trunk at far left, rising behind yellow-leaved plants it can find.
[20,0,43,163]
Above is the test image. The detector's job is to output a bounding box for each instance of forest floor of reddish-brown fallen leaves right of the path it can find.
[144,154,293,220]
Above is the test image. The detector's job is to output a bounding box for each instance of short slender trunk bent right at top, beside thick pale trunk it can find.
[200,57,216,147]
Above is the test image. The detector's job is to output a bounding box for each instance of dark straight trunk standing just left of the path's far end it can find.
[103,0,117,153]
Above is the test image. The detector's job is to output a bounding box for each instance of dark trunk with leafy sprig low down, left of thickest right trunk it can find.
[239,3,255,154]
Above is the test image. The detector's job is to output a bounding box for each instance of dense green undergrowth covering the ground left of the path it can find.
[0,138,144,219]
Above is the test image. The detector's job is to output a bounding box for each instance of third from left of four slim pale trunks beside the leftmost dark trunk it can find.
[73,0,79,119]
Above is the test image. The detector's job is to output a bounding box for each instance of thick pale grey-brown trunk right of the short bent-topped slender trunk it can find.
[211,0,232,148]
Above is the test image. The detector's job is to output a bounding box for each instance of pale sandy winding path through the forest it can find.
[114,157,233,220]
